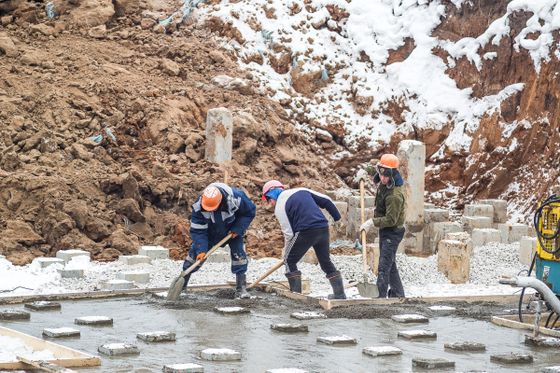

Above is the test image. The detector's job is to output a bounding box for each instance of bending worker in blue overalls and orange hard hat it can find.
[183,183,256,298]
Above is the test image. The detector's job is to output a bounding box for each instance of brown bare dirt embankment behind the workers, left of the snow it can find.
[0,0,340,264]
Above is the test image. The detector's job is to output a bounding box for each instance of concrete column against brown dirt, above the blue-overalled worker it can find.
[205,108,233,163]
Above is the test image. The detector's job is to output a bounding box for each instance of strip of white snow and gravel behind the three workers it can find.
[0,243,526,297]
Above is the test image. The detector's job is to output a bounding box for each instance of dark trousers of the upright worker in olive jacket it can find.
[377,228,404,298]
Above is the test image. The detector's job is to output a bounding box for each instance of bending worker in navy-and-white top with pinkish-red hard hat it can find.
[262,180,346,299]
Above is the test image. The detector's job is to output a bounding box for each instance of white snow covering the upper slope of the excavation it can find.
[197,0,560,156]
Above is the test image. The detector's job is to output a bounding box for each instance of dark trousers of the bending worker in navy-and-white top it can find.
[284,227,336,276]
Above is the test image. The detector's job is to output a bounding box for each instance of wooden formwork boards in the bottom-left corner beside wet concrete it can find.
[0,326,101,370]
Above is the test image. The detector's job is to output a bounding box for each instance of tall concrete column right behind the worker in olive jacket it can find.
[397,140,431,256]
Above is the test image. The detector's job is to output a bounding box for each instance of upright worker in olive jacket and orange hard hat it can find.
[358,154,405,298]
